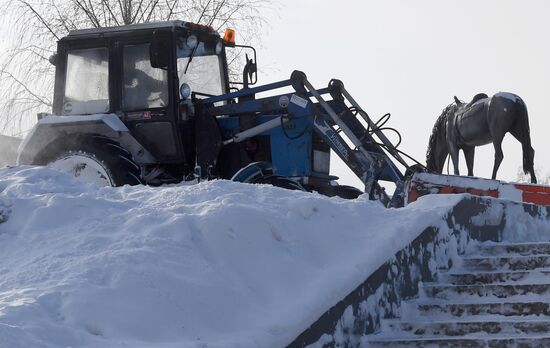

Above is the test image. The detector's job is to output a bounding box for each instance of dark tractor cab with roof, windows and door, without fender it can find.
[48,21,235,165]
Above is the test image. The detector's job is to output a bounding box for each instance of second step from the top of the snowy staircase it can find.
[462,255,550,272]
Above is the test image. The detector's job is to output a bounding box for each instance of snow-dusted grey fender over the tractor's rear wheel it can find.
[17,114,156,165]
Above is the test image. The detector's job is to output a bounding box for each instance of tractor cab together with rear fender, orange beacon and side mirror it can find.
[18,21,264,184]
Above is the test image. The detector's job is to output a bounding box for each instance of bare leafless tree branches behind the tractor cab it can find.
[0,0,271,135]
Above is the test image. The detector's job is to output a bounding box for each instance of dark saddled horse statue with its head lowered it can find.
[426,93,537,183]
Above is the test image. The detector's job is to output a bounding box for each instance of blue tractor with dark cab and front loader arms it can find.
[18,21,409,205]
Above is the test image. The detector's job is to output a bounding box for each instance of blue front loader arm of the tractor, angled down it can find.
[197,71,409,205]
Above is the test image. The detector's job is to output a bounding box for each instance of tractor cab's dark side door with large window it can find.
[116,33,183,163]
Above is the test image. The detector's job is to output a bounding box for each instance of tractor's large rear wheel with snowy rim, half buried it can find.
[36,135,142,186]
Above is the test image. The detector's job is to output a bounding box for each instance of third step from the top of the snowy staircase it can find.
[439,269,550,285]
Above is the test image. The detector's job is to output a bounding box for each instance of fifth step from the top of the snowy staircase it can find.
[416,300,550,319]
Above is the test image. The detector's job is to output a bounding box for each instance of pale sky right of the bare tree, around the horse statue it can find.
[258,0,550,187]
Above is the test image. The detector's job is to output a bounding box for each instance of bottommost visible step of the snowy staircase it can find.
[361,335,550,348]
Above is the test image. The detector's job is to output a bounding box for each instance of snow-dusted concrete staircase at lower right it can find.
[368,243,550,347]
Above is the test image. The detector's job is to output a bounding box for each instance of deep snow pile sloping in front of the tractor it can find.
[0,167,466,347]
